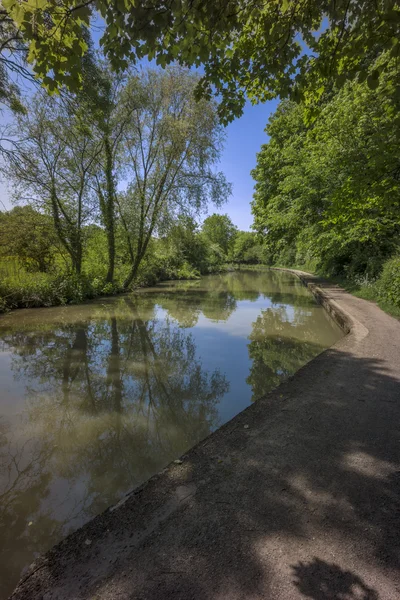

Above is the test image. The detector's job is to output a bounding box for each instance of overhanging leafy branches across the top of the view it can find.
[3,0,400,120]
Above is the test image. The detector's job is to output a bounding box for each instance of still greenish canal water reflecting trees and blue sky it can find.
[0,271,342,598]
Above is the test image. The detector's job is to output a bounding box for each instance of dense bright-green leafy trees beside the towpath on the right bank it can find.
[252,59,400,277]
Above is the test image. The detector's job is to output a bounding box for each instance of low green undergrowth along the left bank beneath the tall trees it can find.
[0,213,224,312]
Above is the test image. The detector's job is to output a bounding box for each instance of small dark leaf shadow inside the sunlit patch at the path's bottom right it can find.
[293,558,379,600]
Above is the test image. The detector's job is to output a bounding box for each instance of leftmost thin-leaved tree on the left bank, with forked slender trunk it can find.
[5,93,102,274]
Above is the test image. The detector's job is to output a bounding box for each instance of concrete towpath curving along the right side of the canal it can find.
[12,277,400,600]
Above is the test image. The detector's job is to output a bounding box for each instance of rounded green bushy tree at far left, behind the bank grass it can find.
[0,206,58,272]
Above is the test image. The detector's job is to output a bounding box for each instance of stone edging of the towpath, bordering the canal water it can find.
[9,267,369,600]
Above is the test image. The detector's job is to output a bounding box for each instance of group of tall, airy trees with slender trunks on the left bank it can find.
[0,67,230,304]
